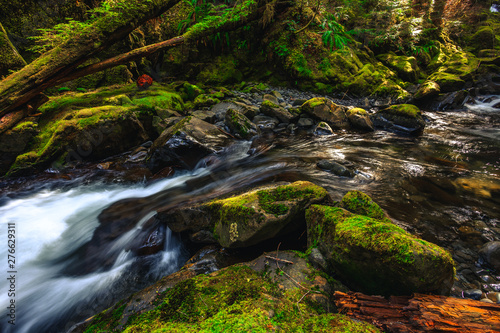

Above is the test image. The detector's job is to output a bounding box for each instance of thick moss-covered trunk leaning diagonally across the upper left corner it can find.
[0,0,180,123]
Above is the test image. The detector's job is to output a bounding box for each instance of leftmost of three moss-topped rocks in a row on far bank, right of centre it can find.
[301,97,349,129]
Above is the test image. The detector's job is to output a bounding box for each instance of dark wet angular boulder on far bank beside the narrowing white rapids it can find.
[147,116,232,172]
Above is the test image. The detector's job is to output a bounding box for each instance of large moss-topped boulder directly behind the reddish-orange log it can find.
[306,205,454,295]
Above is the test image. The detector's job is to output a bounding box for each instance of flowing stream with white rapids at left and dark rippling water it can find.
[0,96,500,333]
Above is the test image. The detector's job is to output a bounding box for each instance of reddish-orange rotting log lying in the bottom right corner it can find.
[334,291,500,333]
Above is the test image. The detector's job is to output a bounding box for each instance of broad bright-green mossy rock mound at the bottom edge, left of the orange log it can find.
[72,262,379,333]
